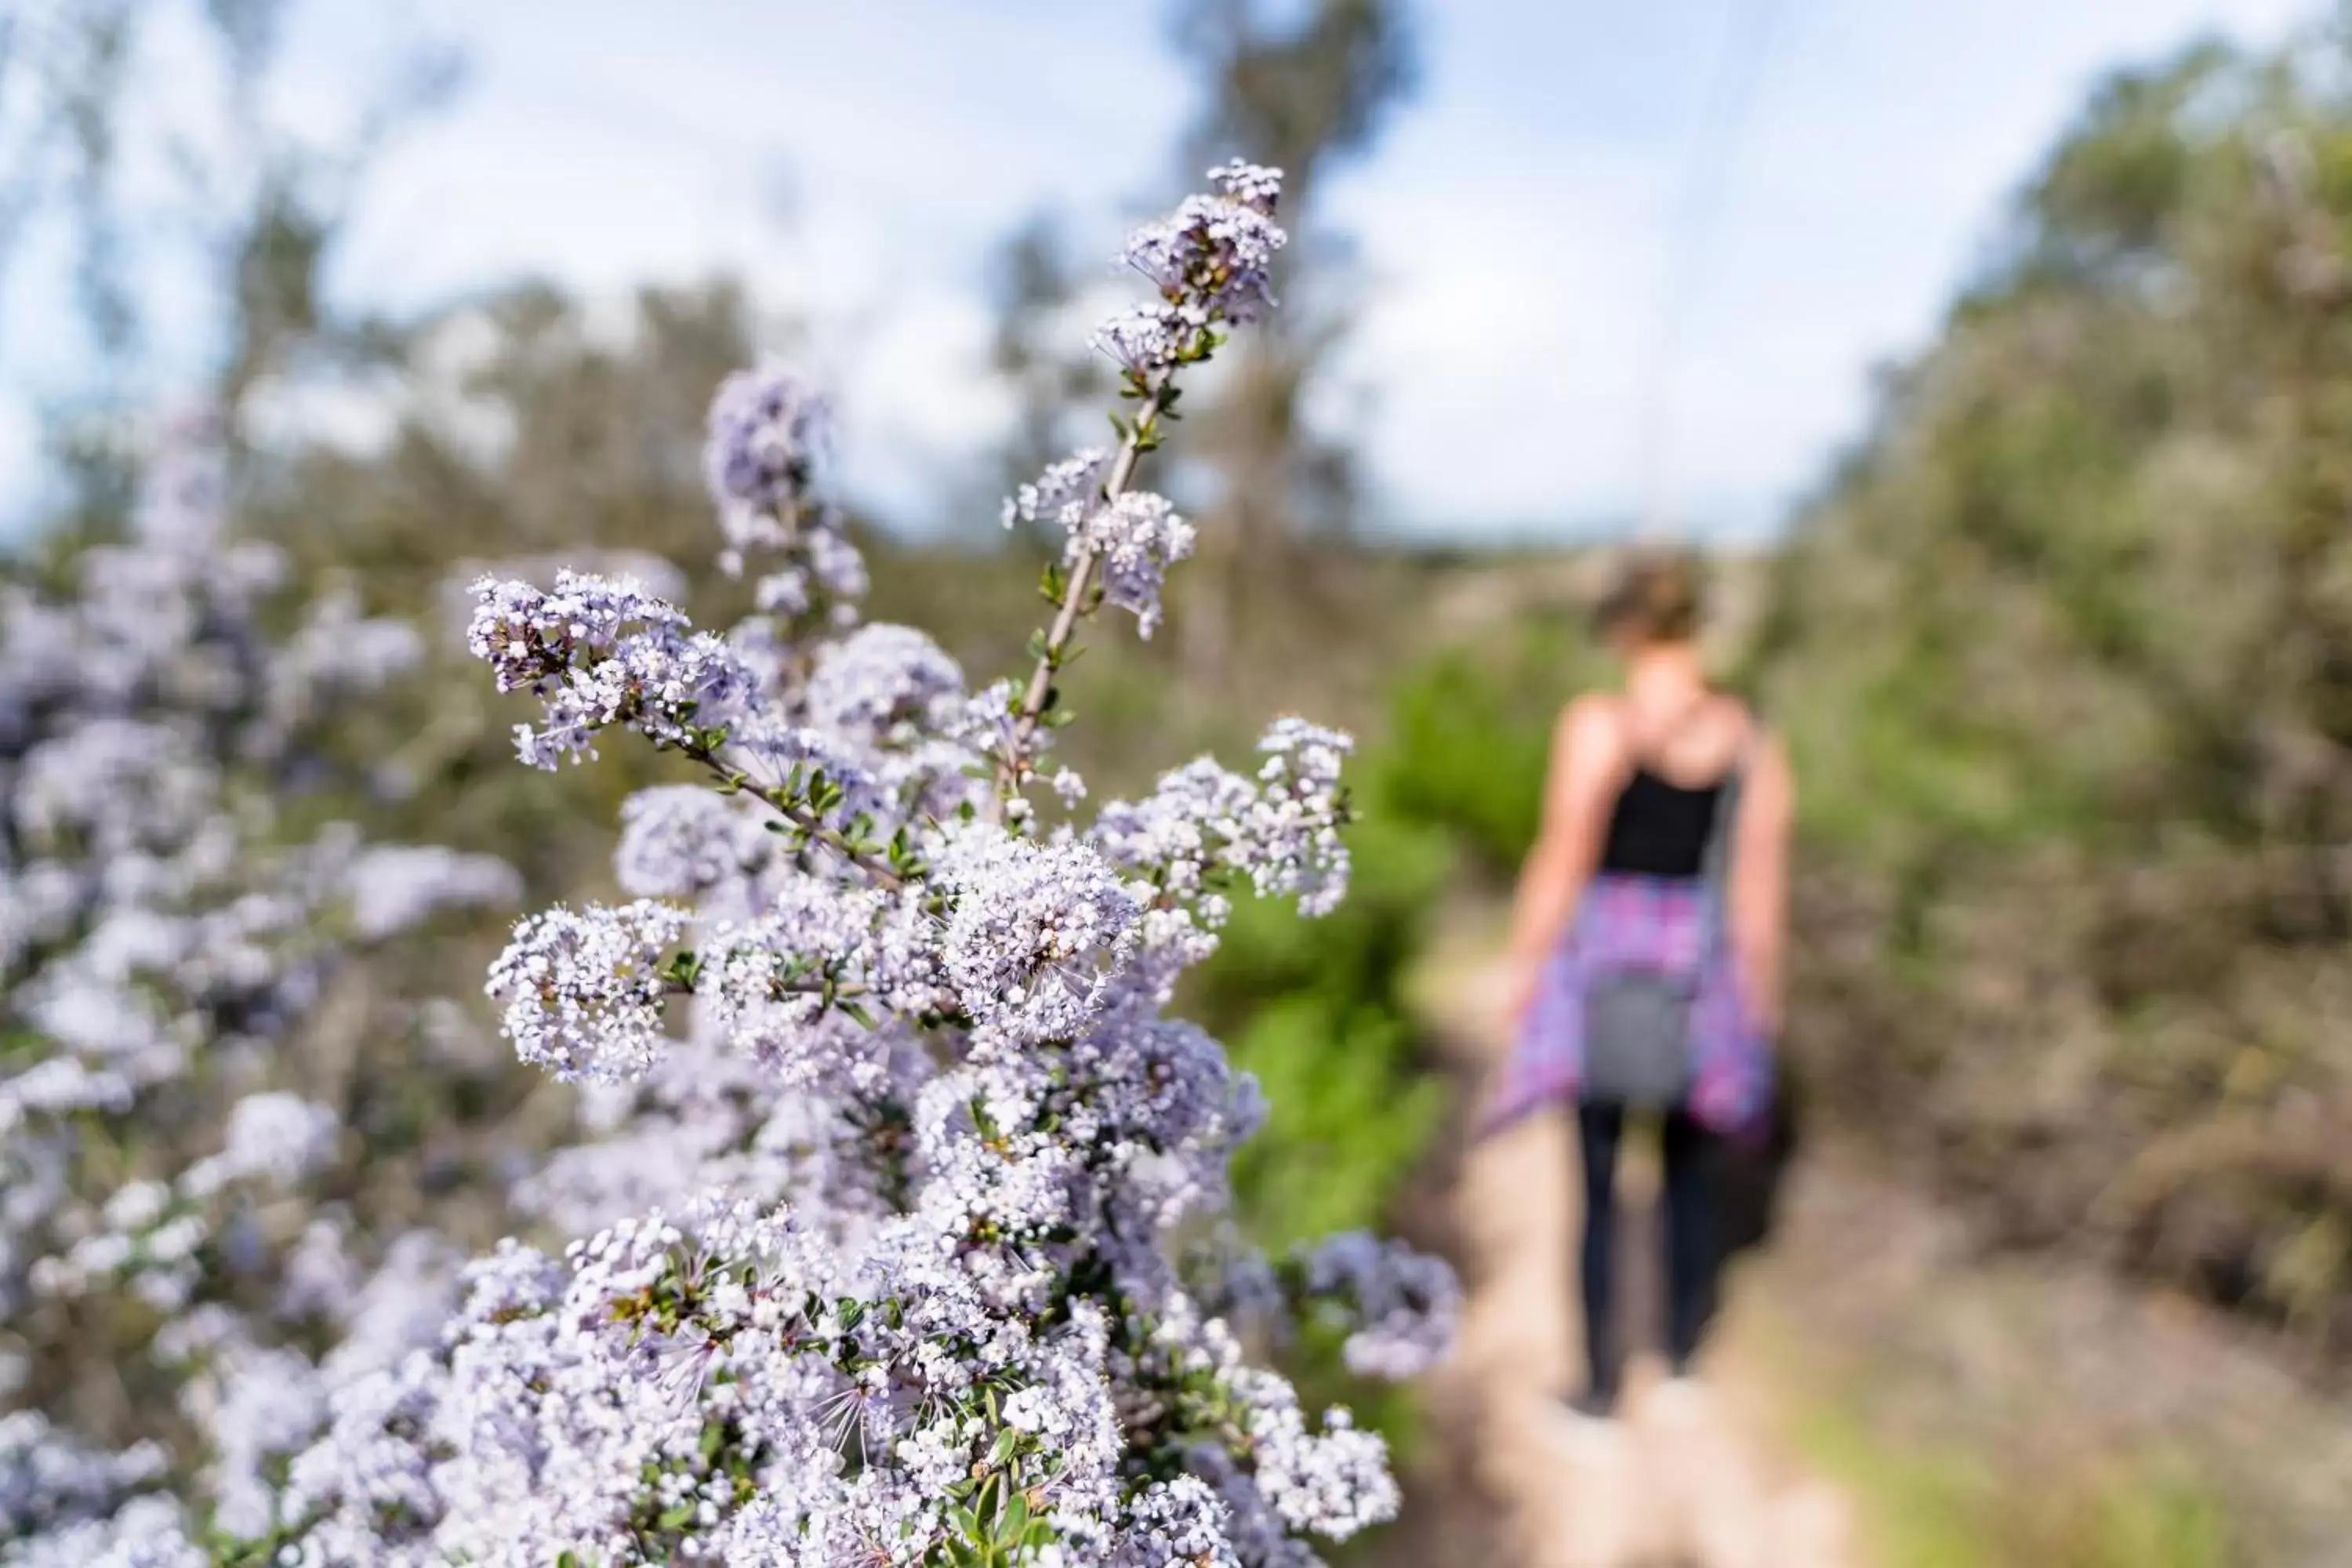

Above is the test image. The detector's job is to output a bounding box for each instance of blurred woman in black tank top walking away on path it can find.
[1489,557,1795,1417]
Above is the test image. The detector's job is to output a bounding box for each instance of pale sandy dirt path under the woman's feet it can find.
[1423,938,1860,1568]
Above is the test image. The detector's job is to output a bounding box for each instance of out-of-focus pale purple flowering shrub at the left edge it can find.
[0,404,520,1561]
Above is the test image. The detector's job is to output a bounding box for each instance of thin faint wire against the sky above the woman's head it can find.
[1637,0,1785,539]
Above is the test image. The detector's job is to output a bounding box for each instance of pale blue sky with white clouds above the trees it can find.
[0,0,2314,541]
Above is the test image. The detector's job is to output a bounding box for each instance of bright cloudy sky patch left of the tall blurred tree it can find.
[310,0,1183,527]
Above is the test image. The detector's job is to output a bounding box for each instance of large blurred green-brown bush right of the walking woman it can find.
[1757,21,2352,1347]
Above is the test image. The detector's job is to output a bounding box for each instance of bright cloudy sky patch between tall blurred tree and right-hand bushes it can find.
[1341,0,2312,534]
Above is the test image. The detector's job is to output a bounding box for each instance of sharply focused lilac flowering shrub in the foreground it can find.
[243,165,1454,1568]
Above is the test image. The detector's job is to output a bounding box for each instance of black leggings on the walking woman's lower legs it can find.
[1576,1105,1722,1401]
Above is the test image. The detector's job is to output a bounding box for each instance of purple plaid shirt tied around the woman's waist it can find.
[1482,872,1771,1133]
